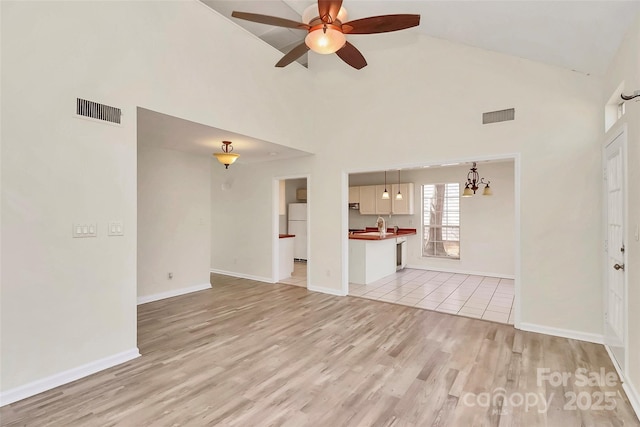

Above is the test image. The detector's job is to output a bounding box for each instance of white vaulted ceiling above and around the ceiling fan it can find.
[202,0,640,75]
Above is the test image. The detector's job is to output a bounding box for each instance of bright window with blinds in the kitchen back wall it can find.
[422,182,460,259]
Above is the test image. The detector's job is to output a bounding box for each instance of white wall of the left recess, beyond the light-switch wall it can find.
[138,145,212,301]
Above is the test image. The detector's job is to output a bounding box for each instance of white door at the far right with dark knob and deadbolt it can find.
[604,132,627,372]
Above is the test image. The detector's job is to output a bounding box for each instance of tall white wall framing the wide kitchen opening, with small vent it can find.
[310,32,603,339]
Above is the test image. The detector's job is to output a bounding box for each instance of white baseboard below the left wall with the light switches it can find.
[0,347,140,406]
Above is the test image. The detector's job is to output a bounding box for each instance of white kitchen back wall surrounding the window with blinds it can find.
[349,161,516,278]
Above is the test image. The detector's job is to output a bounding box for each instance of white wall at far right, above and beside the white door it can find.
[601,15,640,410]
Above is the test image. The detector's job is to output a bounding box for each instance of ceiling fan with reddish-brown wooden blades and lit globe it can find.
[231,0,420,70]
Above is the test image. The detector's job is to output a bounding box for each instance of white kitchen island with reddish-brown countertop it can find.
[349,228,416,285]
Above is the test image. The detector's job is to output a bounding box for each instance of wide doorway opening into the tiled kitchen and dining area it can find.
[343,154,520,325]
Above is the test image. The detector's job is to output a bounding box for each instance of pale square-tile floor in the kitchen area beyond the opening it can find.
[349,269,514,325]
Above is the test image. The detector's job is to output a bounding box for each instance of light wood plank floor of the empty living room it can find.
[0,275,640,427]
